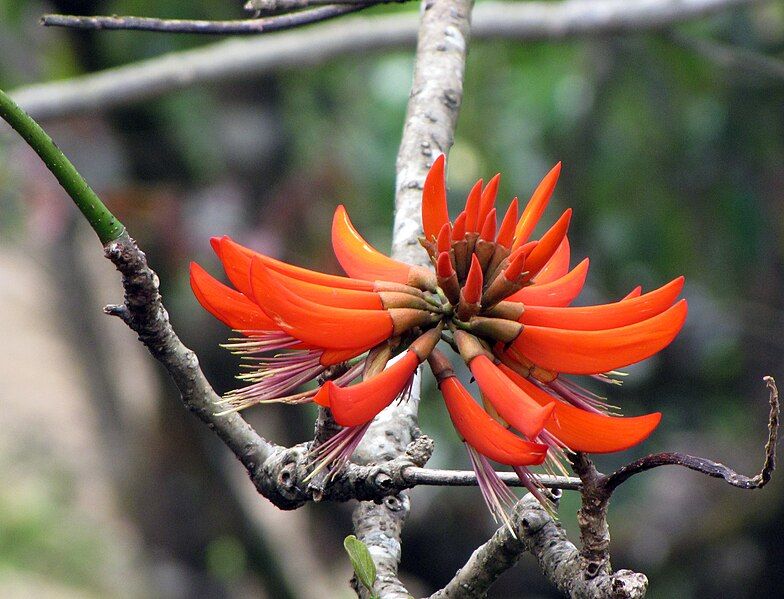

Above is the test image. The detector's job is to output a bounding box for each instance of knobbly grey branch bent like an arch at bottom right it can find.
[430,495,648,599]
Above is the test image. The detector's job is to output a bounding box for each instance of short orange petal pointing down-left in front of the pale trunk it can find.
[324,351,419,426]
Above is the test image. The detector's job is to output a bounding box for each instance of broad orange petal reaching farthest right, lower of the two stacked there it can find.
[512,300,687,374]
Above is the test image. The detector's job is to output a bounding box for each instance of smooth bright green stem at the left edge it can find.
[0,85,125,245]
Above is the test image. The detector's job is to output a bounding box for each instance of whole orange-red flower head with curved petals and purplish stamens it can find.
[191,155,687,522]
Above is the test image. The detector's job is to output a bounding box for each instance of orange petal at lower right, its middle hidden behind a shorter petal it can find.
[499,364,661,453]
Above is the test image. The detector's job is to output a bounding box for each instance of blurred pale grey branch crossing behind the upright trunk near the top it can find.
[11,0,772,119]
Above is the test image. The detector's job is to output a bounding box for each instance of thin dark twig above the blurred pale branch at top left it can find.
[41,2,374,35]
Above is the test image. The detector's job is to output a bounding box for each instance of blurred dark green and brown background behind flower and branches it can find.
[0,0,784,599]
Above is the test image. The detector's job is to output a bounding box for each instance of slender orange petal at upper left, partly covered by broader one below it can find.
[210,236,373,291]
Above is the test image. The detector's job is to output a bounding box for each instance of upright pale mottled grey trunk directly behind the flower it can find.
[354,0,473,599]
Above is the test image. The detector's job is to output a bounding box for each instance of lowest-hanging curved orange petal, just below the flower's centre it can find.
[439,376,547,466]
